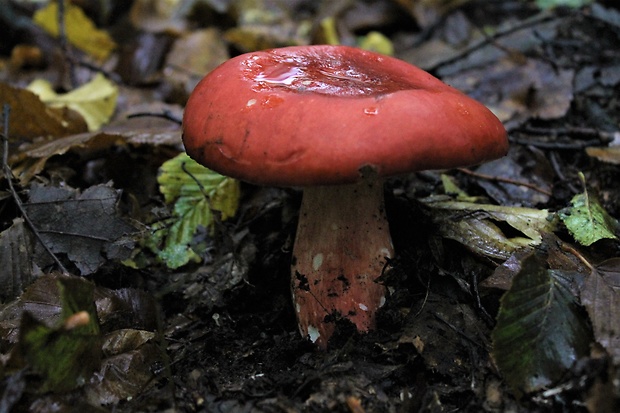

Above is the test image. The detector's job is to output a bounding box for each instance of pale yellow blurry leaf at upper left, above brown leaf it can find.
[27,73,118,131]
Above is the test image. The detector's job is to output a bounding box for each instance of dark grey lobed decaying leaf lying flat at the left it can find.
[25,185,136,275]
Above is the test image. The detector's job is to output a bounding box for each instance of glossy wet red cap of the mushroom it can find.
[183,46,508,186]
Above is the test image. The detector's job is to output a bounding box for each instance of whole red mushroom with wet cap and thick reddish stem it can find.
[183,46,508,347]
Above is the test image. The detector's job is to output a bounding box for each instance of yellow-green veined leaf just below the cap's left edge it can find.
[148,153,240,268]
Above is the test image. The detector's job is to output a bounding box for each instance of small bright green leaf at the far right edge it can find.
[558,175,618,246]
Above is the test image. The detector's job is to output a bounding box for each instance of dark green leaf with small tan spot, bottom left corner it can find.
[19,277,101,392]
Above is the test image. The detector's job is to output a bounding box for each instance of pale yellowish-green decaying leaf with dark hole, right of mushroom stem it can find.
[423,198,555,259]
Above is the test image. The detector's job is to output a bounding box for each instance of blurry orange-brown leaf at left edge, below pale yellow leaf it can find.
[0,82,87,140]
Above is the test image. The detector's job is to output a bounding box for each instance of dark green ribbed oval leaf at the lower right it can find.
[492,255,592,394]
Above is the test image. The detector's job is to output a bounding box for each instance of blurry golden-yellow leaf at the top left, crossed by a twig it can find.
[33,1,116,60]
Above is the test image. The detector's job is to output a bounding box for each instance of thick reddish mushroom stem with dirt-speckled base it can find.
[291,174,394,347]
